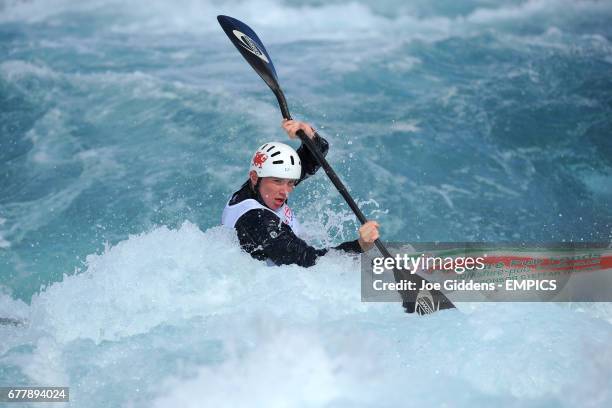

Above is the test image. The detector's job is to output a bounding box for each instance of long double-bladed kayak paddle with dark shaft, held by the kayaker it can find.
[217,15,455,314]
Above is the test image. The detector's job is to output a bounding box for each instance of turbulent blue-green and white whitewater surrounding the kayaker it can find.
[0,0,612,407]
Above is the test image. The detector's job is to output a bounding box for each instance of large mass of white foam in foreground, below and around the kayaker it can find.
[0,223,612,407]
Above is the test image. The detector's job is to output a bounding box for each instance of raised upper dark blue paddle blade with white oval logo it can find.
[217,15,280,93]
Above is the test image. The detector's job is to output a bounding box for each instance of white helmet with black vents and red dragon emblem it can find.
[249,142,302,180]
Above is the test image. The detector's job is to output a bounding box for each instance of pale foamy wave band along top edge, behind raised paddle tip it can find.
[0,0,612,43]
